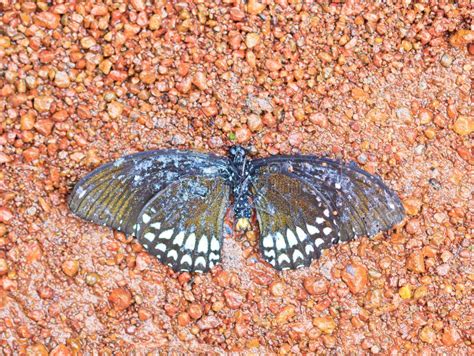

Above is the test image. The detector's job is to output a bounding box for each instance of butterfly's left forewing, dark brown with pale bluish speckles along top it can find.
[69,150,229,234]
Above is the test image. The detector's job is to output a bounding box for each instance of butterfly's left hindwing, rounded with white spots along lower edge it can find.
[135,176,230,272]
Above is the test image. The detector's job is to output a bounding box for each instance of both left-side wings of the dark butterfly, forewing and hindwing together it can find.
[69,150,231,271]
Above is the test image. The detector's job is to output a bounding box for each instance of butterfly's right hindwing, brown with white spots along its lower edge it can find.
[253,173,339,270]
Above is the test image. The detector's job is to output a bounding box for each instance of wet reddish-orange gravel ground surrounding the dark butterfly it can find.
[0,0,474,355]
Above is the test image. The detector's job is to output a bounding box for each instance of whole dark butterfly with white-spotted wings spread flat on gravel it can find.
[69,146,405,272]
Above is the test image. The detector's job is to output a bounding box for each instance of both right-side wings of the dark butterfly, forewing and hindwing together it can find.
[250,156,404,270]
